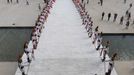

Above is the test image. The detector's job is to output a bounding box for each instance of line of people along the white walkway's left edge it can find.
[18,0,55,75]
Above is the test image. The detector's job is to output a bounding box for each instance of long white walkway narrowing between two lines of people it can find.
[16,0,116,75]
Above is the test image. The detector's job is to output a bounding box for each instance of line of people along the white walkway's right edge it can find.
[73,0,117,75]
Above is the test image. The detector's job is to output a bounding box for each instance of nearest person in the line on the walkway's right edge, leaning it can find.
[105,53,117,75]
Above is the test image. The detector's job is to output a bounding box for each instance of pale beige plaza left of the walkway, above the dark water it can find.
[0,0,45,27]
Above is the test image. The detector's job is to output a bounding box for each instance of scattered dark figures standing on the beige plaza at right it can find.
[80,0,134,29]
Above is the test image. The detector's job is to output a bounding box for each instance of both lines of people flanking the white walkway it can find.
[15,0,120,75]
